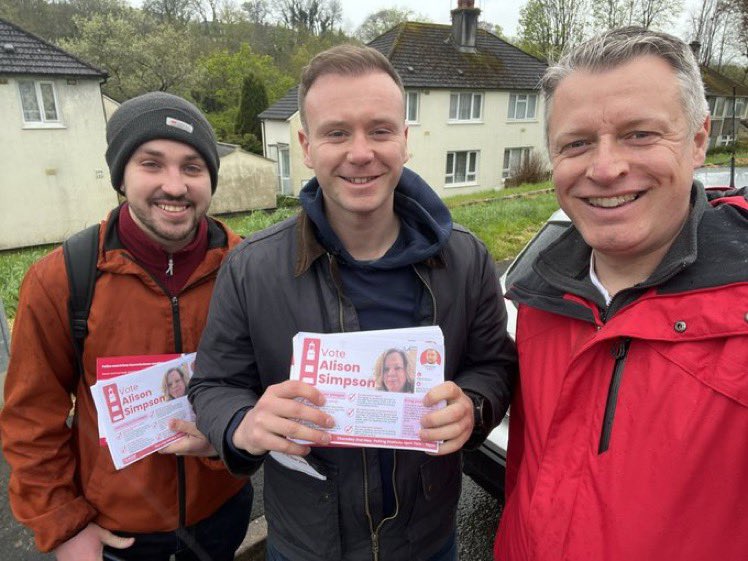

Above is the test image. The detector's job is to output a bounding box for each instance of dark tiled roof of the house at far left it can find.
[0,19,107,78]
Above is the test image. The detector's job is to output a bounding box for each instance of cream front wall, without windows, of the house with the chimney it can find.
[407,90,547,197]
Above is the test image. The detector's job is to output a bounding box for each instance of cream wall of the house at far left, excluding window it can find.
[0,76,117,249]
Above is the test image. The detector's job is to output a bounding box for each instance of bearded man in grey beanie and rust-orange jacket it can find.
[0,92,252,561]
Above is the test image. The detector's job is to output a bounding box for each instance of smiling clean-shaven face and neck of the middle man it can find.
[299,71,408,227]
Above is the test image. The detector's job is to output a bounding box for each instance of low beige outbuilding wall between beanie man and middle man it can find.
[210,150,277,214]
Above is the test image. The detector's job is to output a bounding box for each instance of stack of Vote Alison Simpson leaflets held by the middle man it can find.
[291,326,445,452]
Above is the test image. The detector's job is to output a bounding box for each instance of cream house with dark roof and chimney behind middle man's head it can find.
[259,0,546,196]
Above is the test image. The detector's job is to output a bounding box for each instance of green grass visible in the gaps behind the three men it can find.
[0,188,558,319]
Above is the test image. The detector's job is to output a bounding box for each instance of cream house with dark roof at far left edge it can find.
[0,19,117,249]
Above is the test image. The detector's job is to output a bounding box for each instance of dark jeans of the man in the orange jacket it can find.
[104,484,254,561]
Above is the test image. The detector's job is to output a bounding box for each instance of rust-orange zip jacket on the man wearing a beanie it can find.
[0,209,245,551]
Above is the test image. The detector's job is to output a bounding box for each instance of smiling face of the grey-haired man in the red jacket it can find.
[548,55,709,266]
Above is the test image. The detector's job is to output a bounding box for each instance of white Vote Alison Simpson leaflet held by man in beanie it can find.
[91,353,195,469]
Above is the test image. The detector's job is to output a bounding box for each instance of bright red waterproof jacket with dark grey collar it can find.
[494,188,748,561]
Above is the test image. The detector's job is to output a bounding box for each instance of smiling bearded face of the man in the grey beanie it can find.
[122,139,212,253]
